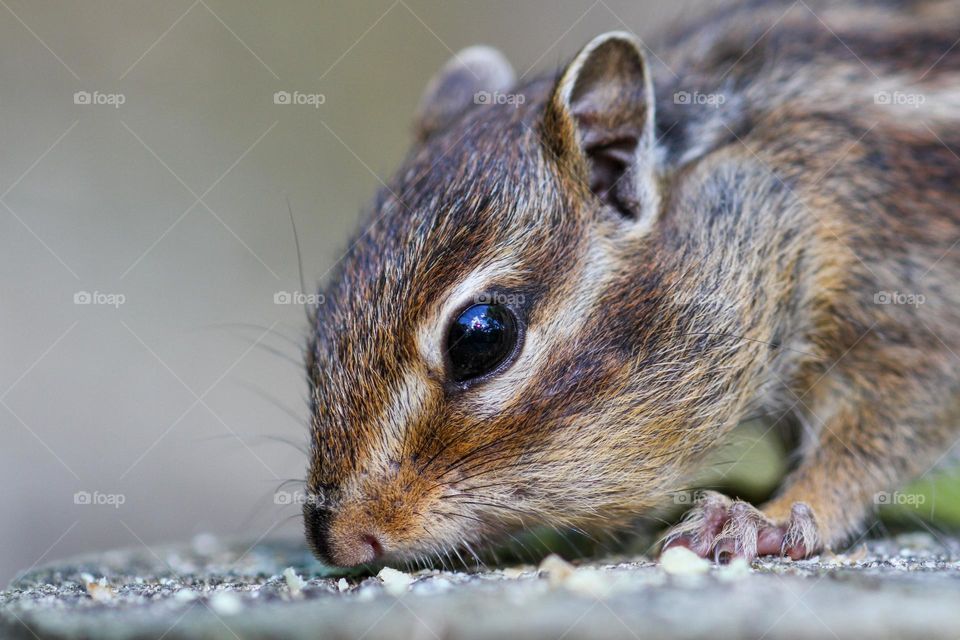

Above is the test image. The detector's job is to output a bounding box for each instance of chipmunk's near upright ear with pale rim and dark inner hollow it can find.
[543,31,660,224]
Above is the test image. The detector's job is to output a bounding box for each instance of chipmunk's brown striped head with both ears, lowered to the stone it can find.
[304,33,756,565]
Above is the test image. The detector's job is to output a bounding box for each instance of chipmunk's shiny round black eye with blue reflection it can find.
[447,304,518,382]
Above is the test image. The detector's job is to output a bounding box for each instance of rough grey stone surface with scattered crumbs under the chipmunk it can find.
[0,534,960,640]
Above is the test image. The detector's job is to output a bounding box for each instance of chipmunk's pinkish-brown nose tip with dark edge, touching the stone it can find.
[303,504,383,567]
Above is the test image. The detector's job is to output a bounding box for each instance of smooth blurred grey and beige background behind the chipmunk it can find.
[0,0,956,585]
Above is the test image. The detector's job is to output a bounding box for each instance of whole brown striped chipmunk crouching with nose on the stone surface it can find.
[304,0,960,566]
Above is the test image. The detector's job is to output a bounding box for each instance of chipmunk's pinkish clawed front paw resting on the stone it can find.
[663,491,822,563]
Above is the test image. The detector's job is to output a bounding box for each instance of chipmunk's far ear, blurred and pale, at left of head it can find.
[417,46,516,140]
